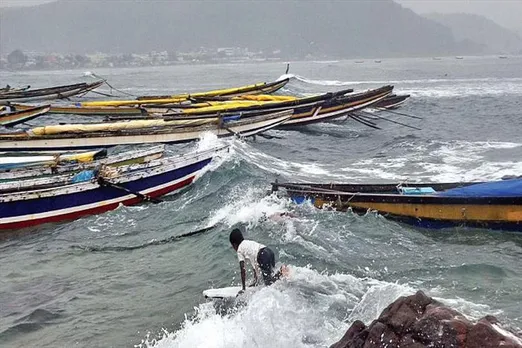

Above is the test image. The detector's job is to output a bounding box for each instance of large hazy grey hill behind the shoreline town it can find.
[0,0,480,58]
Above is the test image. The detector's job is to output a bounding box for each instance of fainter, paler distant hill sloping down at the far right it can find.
[425,13,522,53]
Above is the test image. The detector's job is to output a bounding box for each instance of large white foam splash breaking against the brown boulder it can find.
[140,267,410,348]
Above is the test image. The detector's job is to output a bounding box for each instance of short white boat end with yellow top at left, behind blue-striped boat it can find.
[0,150,107,171]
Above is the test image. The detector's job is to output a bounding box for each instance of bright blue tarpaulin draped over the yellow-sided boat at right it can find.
[439,179,522,197]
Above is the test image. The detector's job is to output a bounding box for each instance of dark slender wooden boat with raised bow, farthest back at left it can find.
[0,80,105,105]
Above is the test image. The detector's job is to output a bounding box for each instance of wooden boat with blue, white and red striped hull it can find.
[0,147,228,230]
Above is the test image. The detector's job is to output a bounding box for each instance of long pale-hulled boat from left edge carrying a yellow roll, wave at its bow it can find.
[0,111,292,151]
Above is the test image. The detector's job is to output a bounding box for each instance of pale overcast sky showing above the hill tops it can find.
[0,0,522,31]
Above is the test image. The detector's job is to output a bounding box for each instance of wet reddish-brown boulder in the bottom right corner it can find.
[330,291,522,348]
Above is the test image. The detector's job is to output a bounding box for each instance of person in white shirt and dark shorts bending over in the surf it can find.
[229,228,281,290]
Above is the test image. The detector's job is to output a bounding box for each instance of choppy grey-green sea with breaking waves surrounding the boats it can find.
[0,57,522,348]
